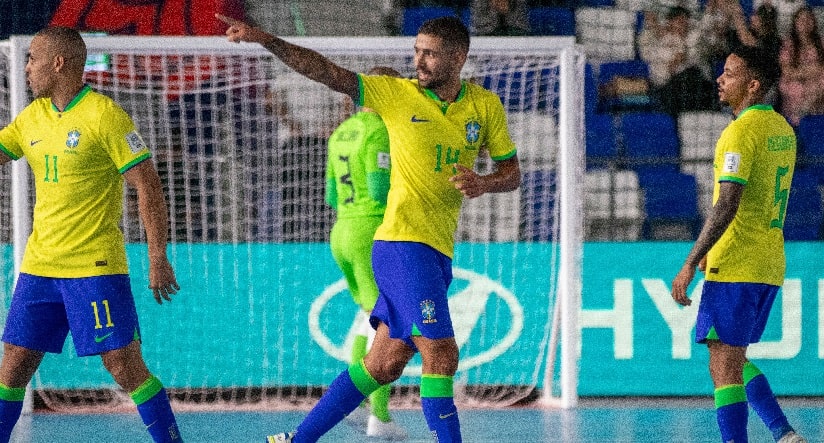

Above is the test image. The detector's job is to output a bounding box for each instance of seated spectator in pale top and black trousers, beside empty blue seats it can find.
[638,6,715,115]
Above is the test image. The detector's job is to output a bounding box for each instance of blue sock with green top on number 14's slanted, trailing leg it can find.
[292,359,380,443]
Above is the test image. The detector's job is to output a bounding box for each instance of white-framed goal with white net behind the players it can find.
[0,36,584,410]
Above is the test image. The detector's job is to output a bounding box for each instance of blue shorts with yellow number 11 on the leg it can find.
[3,273,140,357]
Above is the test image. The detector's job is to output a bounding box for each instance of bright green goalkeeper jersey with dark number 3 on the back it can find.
[326,111,390,219]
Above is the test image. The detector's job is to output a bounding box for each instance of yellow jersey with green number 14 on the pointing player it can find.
[359,75,515,258]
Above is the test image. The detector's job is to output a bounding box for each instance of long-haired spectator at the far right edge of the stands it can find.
[778,6,824,126]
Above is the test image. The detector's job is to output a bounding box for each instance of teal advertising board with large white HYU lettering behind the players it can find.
[0,242,824,396]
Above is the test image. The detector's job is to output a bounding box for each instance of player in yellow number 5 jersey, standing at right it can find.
[672,46,806,443]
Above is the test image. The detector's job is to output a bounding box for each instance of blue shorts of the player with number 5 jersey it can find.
[695,281,780,347]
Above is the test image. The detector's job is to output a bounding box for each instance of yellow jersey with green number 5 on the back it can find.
[706,105,796,286]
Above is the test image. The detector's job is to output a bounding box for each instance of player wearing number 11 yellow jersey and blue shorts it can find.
[0,27,182,442]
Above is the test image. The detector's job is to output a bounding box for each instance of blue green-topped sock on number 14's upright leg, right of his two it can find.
[421,374,461,443]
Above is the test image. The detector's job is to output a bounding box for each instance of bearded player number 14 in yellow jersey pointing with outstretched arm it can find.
[218,16,521,443]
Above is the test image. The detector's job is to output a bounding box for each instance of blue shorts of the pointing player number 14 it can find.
[371,241,455,350]
